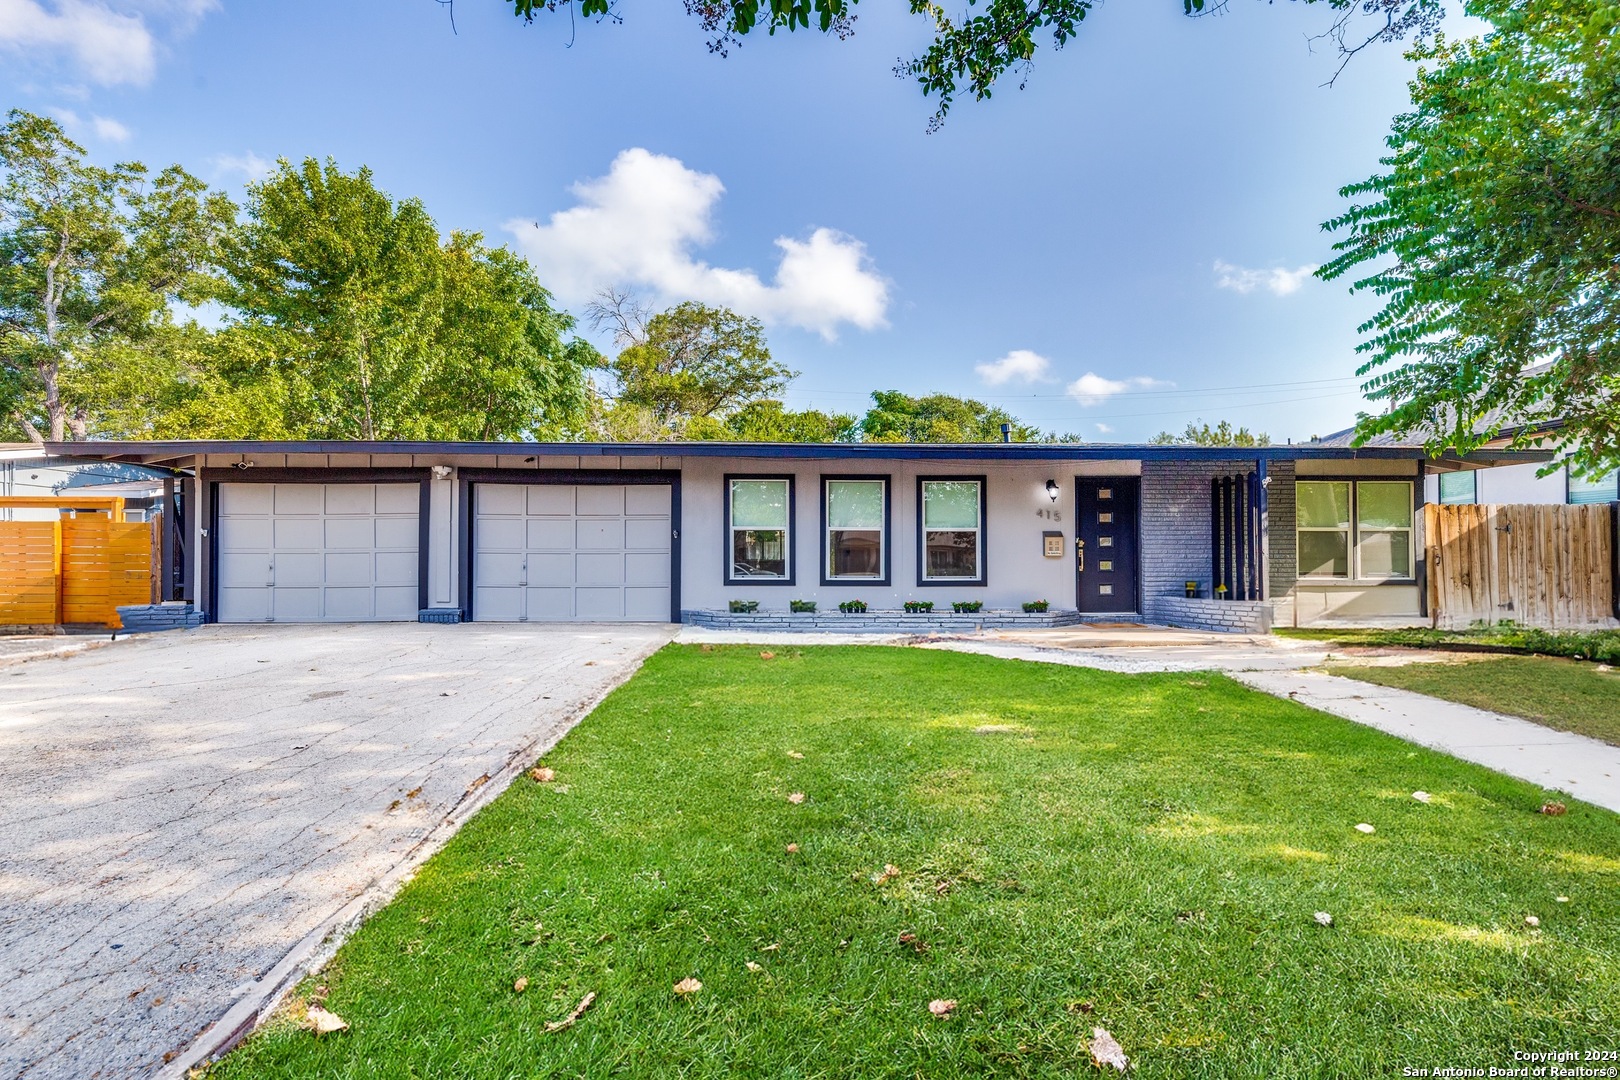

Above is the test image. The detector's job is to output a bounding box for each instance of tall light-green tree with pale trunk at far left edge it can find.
[0,110,235,442]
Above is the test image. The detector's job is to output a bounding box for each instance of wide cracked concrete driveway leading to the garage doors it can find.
[0,623,674,1080]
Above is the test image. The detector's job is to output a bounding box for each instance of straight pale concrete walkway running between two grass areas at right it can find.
[1231,670,1620,813]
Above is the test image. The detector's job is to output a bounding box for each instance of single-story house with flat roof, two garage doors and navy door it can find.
[47,440,1547,630]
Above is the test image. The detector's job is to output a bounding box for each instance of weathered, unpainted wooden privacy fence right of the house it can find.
[1424,504,1620,630]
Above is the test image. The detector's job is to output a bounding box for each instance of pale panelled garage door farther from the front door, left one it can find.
[217,484,421,622]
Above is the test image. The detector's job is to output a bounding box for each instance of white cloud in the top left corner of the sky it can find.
[0,0,219,86]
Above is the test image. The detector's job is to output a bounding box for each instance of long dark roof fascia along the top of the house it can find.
[45,439,1552,465]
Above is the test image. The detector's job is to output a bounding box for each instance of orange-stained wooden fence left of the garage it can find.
[0,497,162,628]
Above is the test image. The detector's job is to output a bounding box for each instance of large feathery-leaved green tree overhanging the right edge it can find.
[1319,0,1620,473]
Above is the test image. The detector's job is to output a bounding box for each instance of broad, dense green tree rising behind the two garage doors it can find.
[214,159,596,439]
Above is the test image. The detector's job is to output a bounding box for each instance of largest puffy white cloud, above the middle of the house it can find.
[507,147,889,338]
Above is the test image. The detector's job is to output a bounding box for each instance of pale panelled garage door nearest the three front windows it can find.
[473,484,671,622]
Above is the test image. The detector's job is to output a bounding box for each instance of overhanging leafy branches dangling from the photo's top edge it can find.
[510,0,1443,131]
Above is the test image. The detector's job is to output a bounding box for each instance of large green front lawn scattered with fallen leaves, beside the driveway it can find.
[209,646,1620,1080]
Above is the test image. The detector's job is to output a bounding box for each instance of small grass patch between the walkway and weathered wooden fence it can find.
[1328,656,1620,746]
